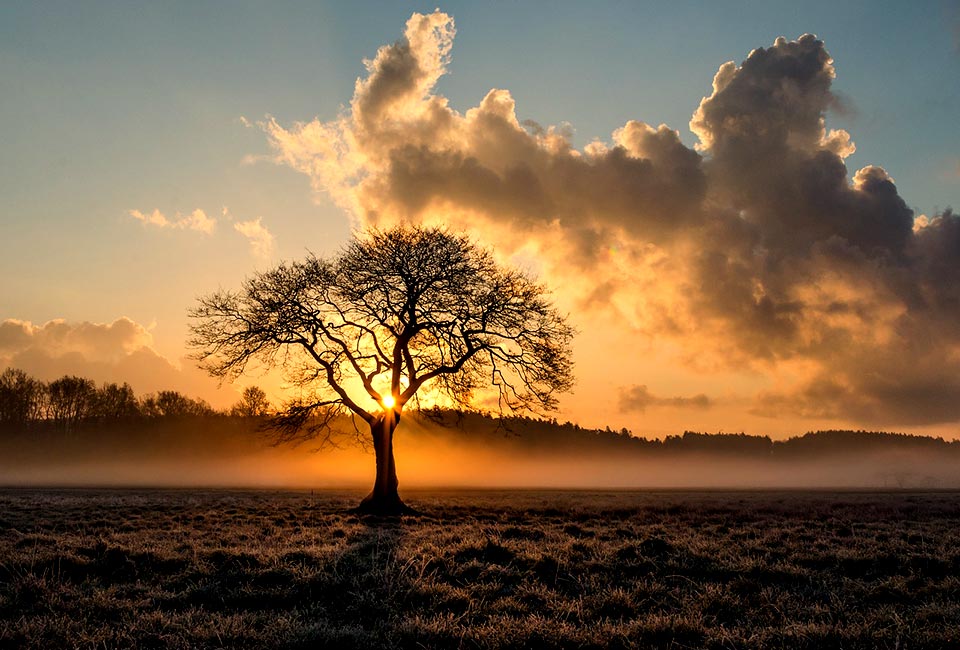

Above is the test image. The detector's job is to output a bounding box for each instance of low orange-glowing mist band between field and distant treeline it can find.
[0,416,960,491]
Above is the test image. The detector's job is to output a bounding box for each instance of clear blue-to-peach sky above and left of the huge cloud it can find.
[0,2,960,432]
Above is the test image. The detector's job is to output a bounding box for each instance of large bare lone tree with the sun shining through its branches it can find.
[190,226,573,514]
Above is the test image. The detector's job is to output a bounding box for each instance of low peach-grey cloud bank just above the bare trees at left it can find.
[0,317,236,406]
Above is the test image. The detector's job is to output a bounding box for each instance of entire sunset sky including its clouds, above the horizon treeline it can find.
[0,2,960,438]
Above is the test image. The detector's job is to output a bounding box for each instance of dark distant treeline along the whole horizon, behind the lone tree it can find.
[0,368,960,459]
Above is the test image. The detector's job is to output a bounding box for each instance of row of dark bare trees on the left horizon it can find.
[0,368,271,430]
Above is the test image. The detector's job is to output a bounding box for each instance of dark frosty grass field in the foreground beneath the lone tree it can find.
[0,489,960,649]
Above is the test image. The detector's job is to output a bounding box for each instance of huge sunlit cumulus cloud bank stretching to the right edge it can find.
[261,11,960,424]
